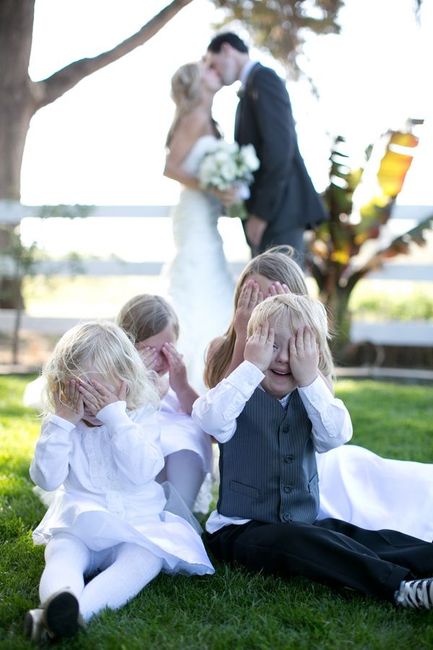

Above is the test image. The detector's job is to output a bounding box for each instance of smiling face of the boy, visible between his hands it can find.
[262,318,297,399]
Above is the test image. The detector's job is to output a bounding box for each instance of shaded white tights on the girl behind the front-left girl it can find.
[157,449,205,510]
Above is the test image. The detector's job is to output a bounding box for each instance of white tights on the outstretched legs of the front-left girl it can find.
[39,534,162,621]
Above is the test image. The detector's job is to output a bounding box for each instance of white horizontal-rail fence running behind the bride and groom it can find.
[0,201,433,347]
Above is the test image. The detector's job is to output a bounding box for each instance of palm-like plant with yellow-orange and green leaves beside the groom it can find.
[308,120,433,362]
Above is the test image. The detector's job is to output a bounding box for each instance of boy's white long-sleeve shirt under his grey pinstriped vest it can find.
[192,361,353,533]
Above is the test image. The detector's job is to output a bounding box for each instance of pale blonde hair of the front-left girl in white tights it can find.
[42,321,159,412]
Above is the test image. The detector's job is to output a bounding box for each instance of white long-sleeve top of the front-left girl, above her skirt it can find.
[30,401,164,510]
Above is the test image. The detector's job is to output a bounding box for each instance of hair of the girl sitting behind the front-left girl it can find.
[116,293,179,345]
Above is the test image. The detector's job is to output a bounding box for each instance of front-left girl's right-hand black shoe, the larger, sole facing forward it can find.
[43,591,80,638]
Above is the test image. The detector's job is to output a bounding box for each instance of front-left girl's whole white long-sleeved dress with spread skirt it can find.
[30,402,214,575]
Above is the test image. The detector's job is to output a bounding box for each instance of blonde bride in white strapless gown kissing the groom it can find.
[163,62,236,392]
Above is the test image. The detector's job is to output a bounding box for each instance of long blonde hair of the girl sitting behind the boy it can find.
[204,246,308,388]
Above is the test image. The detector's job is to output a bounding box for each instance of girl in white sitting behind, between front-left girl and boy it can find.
[117,294,212,513]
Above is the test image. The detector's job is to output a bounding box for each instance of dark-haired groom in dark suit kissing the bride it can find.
[206,32,328,258]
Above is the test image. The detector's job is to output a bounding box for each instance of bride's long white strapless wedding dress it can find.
[163,135,235,393]
